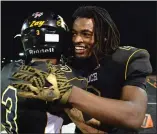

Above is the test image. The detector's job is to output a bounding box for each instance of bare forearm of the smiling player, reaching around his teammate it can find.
[69,88,140,128]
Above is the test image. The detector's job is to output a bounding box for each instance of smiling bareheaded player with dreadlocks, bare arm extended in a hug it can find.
[69,6,152,134]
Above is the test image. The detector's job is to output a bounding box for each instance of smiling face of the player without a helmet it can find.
[72,18,95,58]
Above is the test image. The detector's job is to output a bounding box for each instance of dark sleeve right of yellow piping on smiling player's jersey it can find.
[124,49,152,89]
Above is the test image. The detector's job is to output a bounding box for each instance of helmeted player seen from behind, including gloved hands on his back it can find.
[1,12,87,134]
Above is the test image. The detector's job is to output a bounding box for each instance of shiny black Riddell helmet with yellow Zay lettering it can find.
[21,12,69,58]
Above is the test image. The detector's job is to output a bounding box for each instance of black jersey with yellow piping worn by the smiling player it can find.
[72,46,152,132]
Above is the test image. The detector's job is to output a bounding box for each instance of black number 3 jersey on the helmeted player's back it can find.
[1,61,63,134]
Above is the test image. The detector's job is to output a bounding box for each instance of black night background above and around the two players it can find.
[1,1,157,74]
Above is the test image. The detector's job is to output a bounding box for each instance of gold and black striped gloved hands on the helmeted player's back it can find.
[12,62,87,104]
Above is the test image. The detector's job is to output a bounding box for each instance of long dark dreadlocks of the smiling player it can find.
[72,6,120,58]
